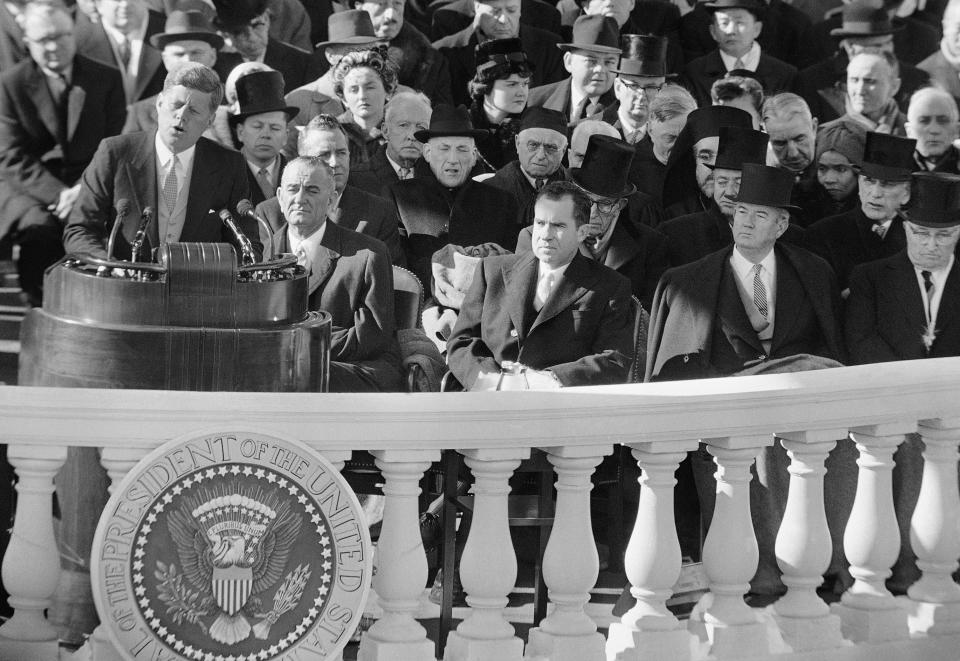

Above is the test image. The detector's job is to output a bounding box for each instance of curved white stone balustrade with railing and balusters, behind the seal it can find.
[0,359,960,661]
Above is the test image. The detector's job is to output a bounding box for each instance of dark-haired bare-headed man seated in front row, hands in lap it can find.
[447,181,634,390]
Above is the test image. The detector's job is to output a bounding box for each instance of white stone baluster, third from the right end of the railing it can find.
[773,429,846,651]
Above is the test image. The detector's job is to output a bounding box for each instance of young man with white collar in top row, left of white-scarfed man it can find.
[683,0,797,107]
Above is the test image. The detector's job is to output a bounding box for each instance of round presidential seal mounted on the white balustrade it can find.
[91,432,372,661]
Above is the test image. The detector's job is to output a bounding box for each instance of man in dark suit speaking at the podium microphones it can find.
[63,62,262,261]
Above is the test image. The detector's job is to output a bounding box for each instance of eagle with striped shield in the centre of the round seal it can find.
[167,485,302,645]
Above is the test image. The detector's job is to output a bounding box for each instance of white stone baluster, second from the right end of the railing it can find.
[831,424,916,643]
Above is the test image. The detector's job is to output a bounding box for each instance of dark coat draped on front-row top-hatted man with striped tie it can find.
[646,242,845,381]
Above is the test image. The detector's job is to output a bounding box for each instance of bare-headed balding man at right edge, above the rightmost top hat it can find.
[904,87,960,174]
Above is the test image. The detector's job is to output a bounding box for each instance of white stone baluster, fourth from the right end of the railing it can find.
[700,435,773,658]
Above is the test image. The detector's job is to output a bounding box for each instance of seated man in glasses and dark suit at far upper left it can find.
[0,5,126,305]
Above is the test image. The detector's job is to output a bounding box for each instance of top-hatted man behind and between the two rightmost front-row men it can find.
[805,132,917,292]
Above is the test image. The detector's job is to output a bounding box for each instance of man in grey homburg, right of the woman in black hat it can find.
[527,15,620,124]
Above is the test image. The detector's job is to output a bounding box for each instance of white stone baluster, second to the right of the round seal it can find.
[443,447,530,661]
